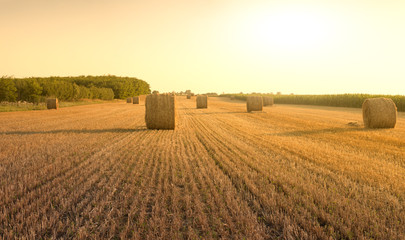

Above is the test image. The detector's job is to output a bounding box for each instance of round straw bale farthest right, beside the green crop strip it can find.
[362,98,397,128]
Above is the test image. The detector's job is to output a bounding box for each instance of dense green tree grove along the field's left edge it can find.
[0,75,150,103]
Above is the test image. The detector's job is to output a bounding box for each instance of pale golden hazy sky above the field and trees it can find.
[0,0,405,95]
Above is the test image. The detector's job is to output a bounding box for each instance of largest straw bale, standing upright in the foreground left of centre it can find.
[145,94,176,129]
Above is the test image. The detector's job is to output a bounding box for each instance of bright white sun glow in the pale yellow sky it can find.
[234,7,339,54]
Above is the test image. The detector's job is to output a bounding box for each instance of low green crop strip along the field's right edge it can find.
[221,94,405,112]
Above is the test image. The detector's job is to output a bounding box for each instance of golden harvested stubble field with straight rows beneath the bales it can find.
[0,97,405,239]
